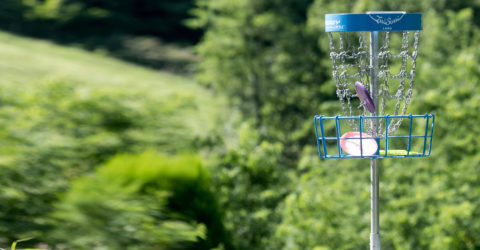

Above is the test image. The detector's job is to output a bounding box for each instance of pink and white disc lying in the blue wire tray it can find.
[340,131,378,156]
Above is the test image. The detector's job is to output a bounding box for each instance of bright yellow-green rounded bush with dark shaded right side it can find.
[54,151,228,249]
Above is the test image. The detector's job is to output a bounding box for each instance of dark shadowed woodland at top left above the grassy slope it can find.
[0,0,202,74]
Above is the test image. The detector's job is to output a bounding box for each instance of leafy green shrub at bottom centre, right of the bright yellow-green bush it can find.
[210,123,290,249]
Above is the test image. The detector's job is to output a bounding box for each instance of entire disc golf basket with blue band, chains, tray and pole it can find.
[314,12,435,249]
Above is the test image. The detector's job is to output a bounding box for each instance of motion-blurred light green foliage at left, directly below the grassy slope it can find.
[0,79,201,240]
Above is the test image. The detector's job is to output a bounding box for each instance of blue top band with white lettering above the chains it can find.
[325,11,422,32]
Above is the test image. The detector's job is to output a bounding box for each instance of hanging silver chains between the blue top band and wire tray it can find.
[328,31,420,134]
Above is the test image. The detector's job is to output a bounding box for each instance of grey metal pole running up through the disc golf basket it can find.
[370,31,380,250]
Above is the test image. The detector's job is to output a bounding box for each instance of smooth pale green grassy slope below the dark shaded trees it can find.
[0,32,224,139]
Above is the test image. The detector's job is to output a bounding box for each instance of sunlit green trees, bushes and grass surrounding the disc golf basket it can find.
[0,0,480,250]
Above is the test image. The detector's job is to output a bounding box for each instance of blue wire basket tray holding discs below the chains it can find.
[314,114,435,159]
